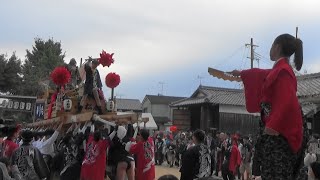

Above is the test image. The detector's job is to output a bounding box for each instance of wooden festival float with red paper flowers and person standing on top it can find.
[26,51,148,128]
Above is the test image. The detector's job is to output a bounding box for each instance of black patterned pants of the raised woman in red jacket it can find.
[252,135,297,180]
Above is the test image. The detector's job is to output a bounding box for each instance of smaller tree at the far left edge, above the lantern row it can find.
[0,53,22,94]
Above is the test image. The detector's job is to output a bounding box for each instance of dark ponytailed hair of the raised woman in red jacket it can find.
[274,34,303,71]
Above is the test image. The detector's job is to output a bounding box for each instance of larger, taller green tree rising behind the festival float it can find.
[20,38,65,96]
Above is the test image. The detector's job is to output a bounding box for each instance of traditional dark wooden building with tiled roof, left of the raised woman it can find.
[170,86,259,134]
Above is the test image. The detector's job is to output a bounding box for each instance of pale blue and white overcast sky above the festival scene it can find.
[0,0,320,100]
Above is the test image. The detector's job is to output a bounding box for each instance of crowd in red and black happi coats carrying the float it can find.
[0,117,155,180]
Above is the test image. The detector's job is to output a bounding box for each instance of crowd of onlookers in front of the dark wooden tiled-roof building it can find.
[154,131,254,179]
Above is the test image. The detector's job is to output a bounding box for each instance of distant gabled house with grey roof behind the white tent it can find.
[142,95,185,130]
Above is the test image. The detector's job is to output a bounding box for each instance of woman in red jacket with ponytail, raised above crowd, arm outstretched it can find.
[231,34,303,180]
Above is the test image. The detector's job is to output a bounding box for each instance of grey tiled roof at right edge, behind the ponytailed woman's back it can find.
[297,73,320,97]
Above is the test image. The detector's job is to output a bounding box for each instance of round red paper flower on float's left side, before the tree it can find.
[50,67,71,86]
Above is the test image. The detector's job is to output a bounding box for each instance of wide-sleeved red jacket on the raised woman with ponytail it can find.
[241,58,302,153]
